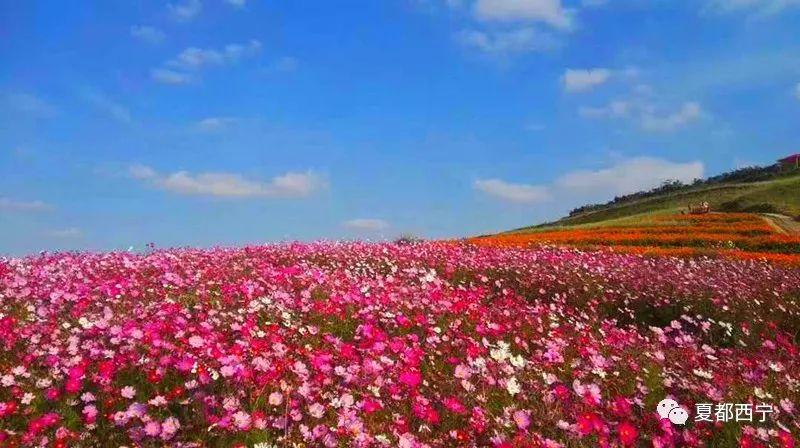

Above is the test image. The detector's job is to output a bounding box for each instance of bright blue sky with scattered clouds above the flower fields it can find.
[0,0,800,254]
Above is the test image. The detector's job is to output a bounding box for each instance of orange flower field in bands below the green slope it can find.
[471,213,800,266]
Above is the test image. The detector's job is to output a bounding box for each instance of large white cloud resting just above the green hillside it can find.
[555,157,705,195]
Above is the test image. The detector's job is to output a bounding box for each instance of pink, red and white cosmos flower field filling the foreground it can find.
[0,243,800,448]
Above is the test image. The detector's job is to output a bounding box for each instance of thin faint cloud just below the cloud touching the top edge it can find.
[456,27,559,55]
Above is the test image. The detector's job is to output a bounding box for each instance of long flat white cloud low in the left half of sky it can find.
[129,165,327,198]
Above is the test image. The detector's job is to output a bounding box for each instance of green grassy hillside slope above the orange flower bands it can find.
[512,175,800,232]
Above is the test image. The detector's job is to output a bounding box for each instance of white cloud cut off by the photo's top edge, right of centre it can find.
[474,0,572,29]
